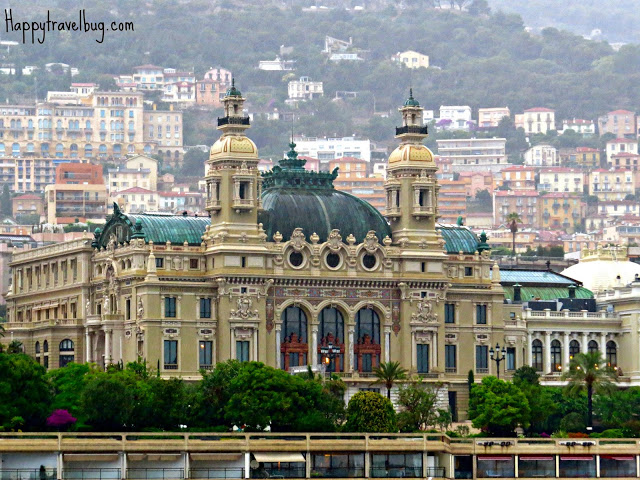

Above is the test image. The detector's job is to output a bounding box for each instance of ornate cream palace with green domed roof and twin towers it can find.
[7,86,640,418]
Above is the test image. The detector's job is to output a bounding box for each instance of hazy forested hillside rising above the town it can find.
[0,0,640,156]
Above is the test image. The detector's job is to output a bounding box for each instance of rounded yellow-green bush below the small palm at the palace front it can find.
[345,392,398,433]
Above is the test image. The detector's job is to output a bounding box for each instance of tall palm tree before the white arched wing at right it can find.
[562,352,618,429]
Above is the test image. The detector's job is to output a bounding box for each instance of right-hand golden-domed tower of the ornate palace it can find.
[385,90,442,250]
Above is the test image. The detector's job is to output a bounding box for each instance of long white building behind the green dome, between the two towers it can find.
[294,137,371,163]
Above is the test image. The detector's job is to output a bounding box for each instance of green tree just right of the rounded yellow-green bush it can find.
[398,382,438,432]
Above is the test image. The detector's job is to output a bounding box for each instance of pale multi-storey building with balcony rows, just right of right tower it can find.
[436,138,508,172]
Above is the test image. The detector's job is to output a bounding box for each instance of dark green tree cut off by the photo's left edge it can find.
[0,353,51,429]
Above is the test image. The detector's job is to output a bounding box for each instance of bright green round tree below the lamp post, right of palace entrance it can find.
[469,376,531,436]
